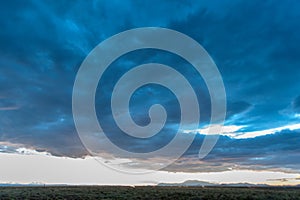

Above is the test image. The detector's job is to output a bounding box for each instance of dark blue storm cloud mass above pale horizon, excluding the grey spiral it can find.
[0,1,300,171]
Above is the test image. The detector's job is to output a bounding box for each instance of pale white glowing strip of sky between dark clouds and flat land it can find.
[0,148,300,185]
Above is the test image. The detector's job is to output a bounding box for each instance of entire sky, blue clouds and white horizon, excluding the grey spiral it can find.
[0,0,300,184]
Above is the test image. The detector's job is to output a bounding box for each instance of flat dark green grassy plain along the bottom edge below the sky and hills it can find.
[0,186,300,200]
